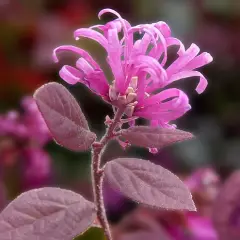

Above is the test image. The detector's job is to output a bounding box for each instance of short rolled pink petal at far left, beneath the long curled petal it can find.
[59,65,83,84]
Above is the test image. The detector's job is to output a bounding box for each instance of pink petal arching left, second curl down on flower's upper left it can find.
[74,28,107,49]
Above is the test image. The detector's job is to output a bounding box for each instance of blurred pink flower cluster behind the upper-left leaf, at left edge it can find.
[0,97,50,190]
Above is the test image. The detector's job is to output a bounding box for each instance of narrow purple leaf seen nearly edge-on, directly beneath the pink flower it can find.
[121,126,193,148]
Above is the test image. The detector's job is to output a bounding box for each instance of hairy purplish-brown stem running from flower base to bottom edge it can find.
[91,108,124,240]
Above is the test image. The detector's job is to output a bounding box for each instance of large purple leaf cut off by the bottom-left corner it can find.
[0,187,96,240]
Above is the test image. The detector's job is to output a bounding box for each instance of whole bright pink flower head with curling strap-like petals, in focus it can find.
[53,9,212,127]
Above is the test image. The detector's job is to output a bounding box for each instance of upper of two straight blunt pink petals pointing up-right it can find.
[166,44,200,76]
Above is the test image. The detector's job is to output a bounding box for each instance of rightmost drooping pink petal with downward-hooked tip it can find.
[167,71,208,94]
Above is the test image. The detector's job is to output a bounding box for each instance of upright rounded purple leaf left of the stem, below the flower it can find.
[34,83,96,151]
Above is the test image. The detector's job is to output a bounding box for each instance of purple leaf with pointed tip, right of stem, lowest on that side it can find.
[104,158,196,211]
